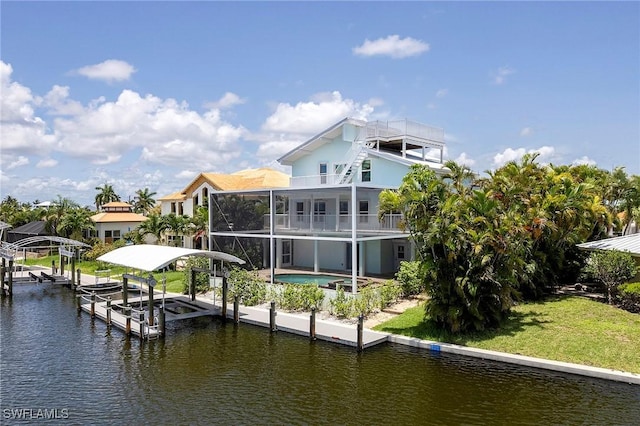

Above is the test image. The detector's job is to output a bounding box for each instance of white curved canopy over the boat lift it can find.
[98,244,245,272]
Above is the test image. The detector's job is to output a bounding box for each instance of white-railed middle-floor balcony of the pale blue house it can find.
[264,213,403,232]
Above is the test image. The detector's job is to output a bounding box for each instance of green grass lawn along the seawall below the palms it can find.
[374,296,640,373]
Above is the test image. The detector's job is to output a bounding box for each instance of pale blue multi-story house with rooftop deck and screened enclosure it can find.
[210,118,446,291]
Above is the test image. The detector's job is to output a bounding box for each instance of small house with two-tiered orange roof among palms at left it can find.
[91,201,147,243]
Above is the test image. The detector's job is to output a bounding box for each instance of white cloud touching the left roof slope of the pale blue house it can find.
[251,91,374,162]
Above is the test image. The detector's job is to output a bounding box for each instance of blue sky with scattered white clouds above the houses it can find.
[0,1,640,206]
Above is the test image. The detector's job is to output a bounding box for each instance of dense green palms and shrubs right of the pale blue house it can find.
[380,154,640,332]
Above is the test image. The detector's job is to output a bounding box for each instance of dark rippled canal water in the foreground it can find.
[0,284,640,425]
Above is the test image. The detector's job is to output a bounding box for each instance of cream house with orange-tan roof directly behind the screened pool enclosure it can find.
[158,167,289,249]
